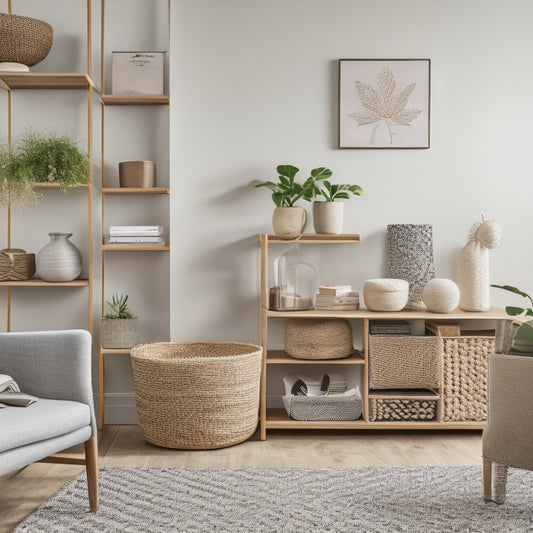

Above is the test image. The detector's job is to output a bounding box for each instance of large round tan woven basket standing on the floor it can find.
[131,342,263,450]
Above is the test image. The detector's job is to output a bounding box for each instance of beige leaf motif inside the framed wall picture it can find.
[348,66,422,145]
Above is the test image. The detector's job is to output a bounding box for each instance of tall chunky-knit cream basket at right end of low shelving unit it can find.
[442,336,495,422]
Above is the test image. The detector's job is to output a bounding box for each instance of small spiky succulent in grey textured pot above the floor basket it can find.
[100,293,138,348]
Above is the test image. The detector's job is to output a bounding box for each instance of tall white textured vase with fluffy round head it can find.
[457,215,501,311]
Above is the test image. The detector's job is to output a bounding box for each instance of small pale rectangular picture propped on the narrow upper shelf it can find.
[111,52,165,96]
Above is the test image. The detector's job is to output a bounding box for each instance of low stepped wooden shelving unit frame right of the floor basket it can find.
[259,234,506,440]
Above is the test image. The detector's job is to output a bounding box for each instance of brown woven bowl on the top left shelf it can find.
[0,13,54,67]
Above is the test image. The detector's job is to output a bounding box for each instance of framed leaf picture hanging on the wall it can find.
[339,59,431,148]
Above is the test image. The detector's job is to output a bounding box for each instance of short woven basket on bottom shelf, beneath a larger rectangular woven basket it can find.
[368,390,439,422]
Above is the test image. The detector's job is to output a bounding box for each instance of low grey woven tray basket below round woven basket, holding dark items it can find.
[282,391,363,420]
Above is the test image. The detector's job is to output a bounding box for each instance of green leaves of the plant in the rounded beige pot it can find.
[252,165,331,207]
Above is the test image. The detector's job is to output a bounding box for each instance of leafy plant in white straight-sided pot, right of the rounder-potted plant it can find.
[304,168,363,234]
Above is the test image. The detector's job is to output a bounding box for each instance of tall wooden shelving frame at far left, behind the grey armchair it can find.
[0,0,95,332]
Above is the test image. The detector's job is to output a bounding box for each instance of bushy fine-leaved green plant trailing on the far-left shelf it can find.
[0,133,90,205]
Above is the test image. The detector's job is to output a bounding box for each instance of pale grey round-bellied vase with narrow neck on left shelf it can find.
[35,233,82,282]
